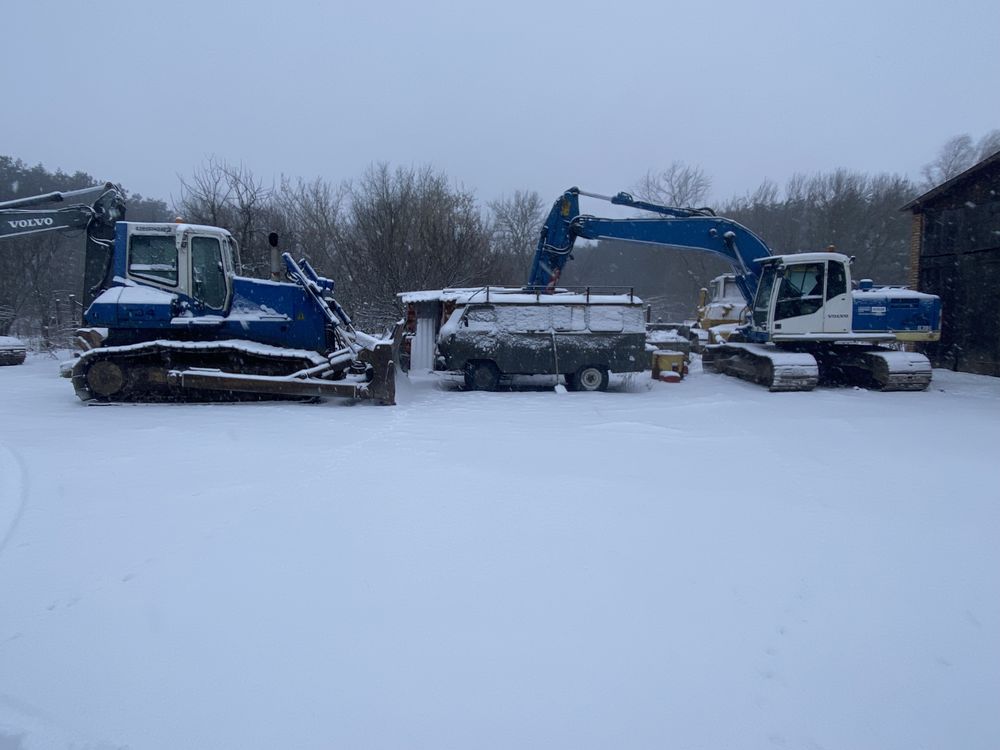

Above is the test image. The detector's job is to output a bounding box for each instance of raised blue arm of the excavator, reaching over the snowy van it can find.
[527,188,771,304]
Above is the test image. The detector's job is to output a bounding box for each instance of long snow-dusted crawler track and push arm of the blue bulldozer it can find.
[70,340,394,403]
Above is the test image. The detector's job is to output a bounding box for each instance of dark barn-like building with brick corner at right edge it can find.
[903,151,1000,376]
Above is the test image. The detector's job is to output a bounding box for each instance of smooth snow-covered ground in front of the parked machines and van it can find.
[0,356,1000,750]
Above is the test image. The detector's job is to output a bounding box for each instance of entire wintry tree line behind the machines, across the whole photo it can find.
[0,130,1000,345]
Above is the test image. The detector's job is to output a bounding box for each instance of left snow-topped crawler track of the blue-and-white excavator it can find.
[702,343,819,391]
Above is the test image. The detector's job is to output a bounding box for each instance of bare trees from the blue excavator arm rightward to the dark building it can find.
[563,129,1000,322]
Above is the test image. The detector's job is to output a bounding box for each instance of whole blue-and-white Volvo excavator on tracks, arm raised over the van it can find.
[526,188,941,391]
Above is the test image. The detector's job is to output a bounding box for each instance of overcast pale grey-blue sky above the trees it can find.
[0,0,1000,207]
